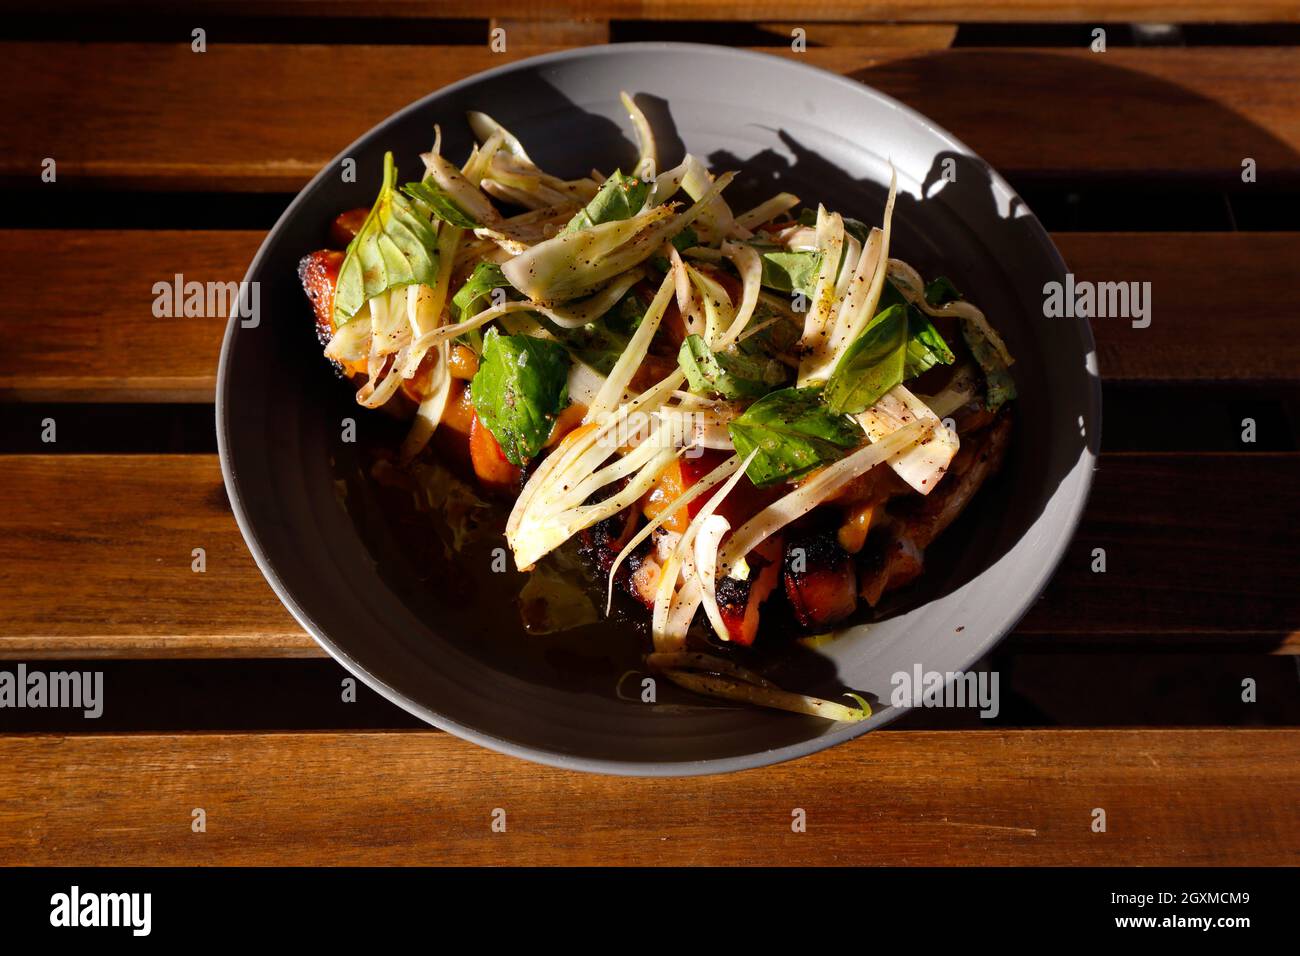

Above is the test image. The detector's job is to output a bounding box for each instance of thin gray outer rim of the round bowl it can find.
[215,40,1101,777]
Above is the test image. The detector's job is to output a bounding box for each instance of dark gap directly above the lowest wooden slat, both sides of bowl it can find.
[0,655,1300,735]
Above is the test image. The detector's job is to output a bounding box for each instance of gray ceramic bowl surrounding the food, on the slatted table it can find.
[217,43,1100,775]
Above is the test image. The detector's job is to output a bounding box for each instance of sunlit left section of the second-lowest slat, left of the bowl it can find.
[0,455,306,657]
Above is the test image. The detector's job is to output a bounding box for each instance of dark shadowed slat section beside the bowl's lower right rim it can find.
[1017,453,1300,642]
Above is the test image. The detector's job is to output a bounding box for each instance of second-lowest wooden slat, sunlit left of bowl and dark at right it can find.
[0,454,1300,659]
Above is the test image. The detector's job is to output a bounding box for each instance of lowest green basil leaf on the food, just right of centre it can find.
[727,388,863,486]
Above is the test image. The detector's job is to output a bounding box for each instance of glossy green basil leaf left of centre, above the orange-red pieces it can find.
[469,329,569,466]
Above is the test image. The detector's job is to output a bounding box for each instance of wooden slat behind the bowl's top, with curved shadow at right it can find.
[0,38,1300,190]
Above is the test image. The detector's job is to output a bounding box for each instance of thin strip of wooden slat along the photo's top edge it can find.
[12,0,1300,23]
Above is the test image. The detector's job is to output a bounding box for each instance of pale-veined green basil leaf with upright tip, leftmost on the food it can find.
[334,152,438,328]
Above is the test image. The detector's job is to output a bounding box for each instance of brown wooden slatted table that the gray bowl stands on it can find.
[0,7,1300,865]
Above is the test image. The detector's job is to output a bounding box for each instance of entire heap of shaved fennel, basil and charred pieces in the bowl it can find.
[299,100,1014,721]
